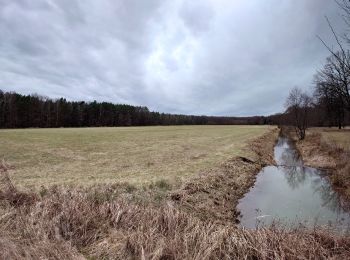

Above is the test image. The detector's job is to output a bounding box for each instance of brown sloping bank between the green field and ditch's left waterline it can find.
[170,128,279,224]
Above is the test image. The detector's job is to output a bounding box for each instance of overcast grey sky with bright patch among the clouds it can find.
[0,0,345,116]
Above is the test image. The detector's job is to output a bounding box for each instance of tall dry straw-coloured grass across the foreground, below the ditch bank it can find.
[0,161,350,259]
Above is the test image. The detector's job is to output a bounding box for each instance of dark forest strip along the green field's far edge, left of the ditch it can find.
[0,90,268,128]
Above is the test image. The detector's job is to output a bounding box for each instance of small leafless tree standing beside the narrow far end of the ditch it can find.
[285,87,312,140]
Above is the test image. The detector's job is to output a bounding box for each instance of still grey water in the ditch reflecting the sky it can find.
[238,137,350,231]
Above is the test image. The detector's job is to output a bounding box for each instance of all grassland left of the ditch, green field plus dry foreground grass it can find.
[0,126,350,259]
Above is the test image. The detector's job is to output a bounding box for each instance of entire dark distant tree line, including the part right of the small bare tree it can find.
[0,89,350,128]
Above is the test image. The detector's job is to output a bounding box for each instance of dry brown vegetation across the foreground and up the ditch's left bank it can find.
[0,129,350,259]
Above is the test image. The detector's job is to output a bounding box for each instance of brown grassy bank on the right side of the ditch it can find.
[283,129,350,201]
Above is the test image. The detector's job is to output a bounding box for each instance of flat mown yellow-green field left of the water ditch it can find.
[0,126,271,188]
